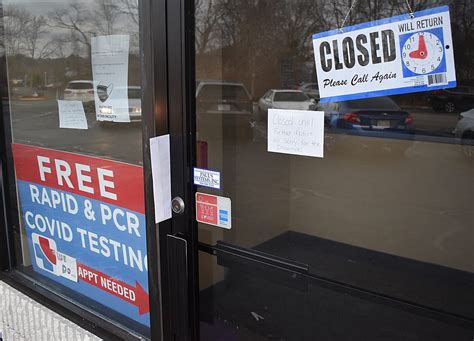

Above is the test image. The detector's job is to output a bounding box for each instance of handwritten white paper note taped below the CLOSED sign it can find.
[268,109,324,157]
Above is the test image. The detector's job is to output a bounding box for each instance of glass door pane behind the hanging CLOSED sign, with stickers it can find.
[193,0,474,340]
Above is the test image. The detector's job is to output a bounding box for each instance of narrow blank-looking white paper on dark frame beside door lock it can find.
[150,135,172,224]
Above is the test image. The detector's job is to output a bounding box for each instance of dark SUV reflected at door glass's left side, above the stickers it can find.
[196,80,253,138]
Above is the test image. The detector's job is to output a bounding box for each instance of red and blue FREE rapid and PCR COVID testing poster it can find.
[13,144,150,326]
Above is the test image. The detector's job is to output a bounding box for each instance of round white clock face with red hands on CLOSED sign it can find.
[402,31,444,75]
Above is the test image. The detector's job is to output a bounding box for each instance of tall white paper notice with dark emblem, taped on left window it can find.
[91,35,130,122]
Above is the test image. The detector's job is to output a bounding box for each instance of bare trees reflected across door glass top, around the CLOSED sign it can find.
[195,0,474,96]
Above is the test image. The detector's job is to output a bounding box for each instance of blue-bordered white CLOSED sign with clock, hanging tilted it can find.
[313,6,456,103]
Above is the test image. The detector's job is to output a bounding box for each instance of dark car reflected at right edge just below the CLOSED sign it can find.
[428,86,474,112]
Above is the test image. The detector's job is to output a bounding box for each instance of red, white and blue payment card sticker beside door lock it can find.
[196,192,232,230]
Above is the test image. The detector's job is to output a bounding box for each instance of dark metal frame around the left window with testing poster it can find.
[0,0,179,340]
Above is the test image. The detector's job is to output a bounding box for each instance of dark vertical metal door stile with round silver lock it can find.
[160,0,199,340]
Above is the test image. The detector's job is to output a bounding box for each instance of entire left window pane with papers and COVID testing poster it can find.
[1,0,150,335]
